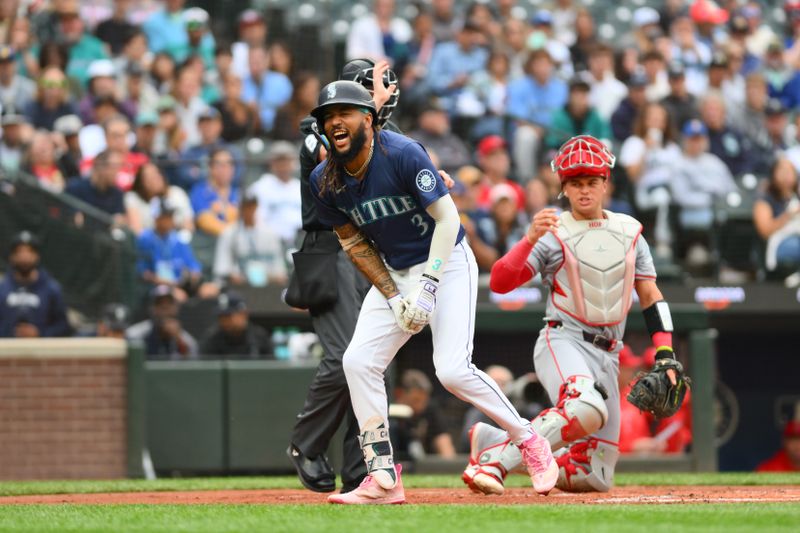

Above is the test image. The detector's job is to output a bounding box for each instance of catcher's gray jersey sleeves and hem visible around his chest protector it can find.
[528,210,656,339]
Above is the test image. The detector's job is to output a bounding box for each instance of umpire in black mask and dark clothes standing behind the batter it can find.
[286,59,400,492]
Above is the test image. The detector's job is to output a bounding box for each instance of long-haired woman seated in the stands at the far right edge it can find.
[753,158,800,270]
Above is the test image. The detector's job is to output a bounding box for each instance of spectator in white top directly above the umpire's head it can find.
[345,0,412,65]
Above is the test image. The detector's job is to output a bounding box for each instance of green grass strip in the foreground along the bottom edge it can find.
[0,504,800,533]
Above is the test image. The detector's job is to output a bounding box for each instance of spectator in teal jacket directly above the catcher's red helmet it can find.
[545,77,611,150]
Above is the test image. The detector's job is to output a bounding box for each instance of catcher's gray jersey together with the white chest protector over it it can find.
[528,211,656,339]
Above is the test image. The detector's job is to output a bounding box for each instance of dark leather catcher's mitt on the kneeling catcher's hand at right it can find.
[628,358,692,419]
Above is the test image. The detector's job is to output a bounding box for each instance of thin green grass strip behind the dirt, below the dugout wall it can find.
[0,473,800,496]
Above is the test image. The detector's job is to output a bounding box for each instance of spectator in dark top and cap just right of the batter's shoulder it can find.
[408,99,470,173]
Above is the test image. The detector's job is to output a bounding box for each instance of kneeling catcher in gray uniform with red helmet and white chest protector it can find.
[462,135,689,494]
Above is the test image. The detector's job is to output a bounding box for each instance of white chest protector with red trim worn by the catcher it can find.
[552,211,642,326]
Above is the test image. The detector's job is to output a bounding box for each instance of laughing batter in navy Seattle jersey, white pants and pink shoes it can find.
[310,81,558,504]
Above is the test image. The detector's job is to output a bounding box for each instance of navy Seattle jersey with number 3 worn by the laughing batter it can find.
[311,131,464,270]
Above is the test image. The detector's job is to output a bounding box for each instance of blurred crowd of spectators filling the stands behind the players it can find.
[0,0,800,332]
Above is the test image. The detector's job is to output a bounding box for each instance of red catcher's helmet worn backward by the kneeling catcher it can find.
[550,135,617,183]
